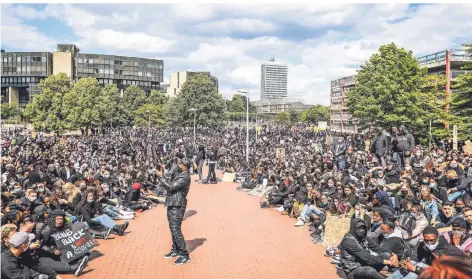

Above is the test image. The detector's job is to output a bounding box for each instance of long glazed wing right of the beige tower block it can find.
[75,53,164,91]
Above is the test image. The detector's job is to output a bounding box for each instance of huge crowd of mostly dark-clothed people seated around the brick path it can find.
[1,124,472,279]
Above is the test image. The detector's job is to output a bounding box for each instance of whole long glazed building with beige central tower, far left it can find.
[1,44,164,119]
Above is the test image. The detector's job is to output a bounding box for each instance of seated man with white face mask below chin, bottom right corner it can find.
[401,227,466,278]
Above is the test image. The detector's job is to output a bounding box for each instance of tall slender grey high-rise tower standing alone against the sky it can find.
[261,58,288,100]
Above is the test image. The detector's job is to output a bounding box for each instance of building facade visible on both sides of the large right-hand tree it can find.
[330,49,472,133]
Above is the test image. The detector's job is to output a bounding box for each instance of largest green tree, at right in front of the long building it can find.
[347,43,445,135]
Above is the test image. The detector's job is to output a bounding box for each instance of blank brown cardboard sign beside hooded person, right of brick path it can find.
[323,214,351,247]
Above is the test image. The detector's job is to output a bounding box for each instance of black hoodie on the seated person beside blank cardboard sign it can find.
[340,218,383,274]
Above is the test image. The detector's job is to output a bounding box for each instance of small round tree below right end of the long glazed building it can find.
[119,85,147,125]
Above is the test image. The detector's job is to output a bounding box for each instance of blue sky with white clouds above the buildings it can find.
[1,3,472,105]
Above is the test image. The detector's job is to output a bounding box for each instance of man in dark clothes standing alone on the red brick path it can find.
[157,152,190,265]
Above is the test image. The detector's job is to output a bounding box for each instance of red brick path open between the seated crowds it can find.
[63,176,338,279]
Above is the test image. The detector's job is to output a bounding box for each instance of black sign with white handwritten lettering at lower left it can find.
[51,223,96,262]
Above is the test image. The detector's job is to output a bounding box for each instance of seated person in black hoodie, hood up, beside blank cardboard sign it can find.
[340,218,398,279]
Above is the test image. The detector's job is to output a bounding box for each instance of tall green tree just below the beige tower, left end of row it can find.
[22,73,73,132]
